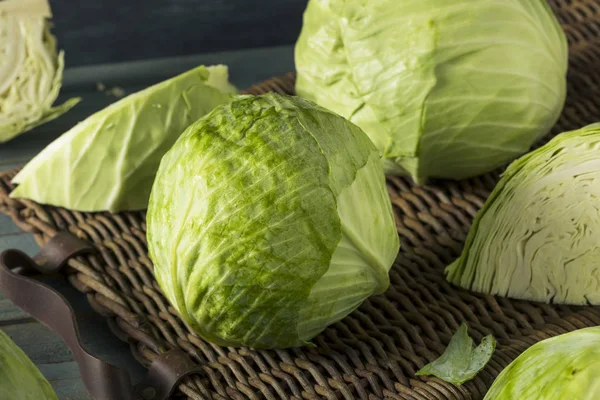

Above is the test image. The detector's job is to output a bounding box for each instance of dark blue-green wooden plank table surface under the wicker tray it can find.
[0,46,294,400]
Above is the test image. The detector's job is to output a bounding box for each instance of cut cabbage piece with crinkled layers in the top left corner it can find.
[0,0,80,143]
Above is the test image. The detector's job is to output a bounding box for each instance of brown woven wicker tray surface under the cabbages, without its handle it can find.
[0,0,600,399]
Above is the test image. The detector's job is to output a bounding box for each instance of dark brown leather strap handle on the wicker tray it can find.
[0,232,199,400]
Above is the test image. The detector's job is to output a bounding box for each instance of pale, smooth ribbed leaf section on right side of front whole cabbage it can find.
[298,148,399,340]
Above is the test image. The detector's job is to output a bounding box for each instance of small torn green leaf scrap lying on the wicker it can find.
[417,323,496,385]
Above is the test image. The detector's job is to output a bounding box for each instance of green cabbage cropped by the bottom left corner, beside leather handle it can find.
[0,330,58,400]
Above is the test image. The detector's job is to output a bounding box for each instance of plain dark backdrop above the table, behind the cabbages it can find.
[50,0,307,67]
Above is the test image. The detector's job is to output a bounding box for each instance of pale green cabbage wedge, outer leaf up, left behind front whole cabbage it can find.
[11,66,235,212]
